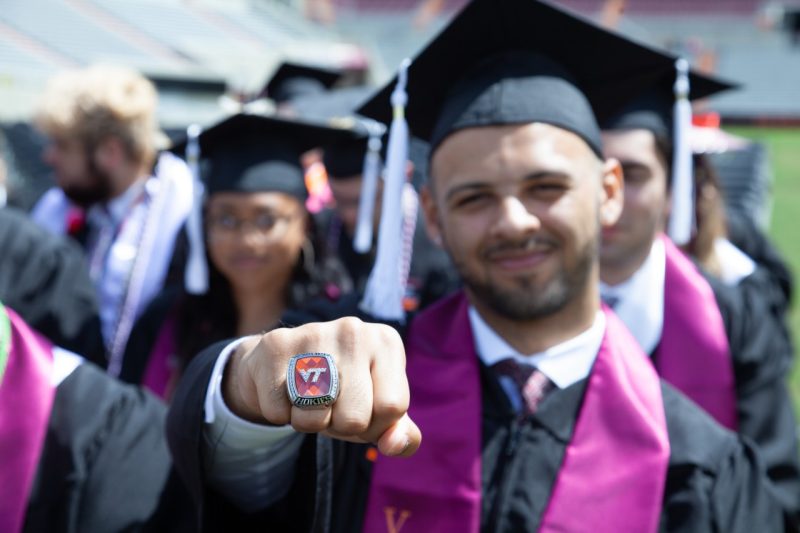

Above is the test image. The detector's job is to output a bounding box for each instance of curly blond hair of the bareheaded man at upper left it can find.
[34,65,158,163]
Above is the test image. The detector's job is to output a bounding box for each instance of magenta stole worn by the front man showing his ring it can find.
[364,293,669,533]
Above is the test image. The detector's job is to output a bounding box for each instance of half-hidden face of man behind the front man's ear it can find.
[600,130,669,274]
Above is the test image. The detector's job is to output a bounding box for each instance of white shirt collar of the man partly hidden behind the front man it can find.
[600,239,667,354]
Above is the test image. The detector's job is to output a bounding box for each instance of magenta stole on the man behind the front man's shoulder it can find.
[653,236,738,431]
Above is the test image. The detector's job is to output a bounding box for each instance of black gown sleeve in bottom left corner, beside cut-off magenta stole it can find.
[24,364,196,533]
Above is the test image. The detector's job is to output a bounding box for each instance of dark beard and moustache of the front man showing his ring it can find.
[454,238,598,321]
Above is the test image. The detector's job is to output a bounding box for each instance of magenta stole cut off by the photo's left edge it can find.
[0,304,55,533]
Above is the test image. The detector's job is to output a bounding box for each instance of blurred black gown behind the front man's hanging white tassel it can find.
[317,206,460,310]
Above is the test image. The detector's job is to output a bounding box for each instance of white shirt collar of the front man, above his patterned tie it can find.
[469,306,606,389]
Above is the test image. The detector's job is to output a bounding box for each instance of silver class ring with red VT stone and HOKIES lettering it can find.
[286,352,339,409]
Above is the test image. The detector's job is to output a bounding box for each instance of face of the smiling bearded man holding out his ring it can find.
[424,123,621,320]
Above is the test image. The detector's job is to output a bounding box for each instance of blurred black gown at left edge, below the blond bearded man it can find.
[0,207,105,366]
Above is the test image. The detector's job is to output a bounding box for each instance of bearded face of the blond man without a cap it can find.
[43,136,111,207]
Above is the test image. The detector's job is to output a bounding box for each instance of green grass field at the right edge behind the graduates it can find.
[728,128,800,418]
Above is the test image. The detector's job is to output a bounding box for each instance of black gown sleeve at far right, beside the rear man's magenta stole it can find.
[708,278,800,523]
